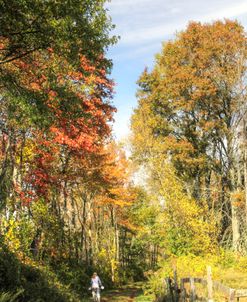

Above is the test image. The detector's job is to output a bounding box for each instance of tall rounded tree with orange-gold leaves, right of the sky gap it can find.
[133,20,246,249]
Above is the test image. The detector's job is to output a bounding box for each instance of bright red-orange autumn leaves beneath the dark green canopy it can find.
[2,42,115,202]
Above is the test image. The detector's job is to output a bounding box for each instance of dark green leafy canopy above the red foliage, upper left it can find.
[0,0,116,64]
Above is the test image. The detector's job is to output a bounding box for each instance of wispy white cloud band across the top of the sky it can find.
[109,0,247,46]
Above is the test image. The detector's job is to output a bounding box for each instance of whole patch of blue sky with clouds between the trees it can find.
[107,0,247,140]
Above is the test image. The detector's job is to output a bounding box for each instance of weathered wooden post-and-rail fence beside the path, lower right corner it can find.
[156,266,247,302]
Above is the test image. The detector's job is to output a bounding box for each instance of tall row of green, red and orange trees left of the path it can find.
[0,0,148,301]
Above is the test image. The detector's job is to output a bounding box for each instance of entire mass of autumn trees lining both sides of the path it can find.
[0,0,247,302]
